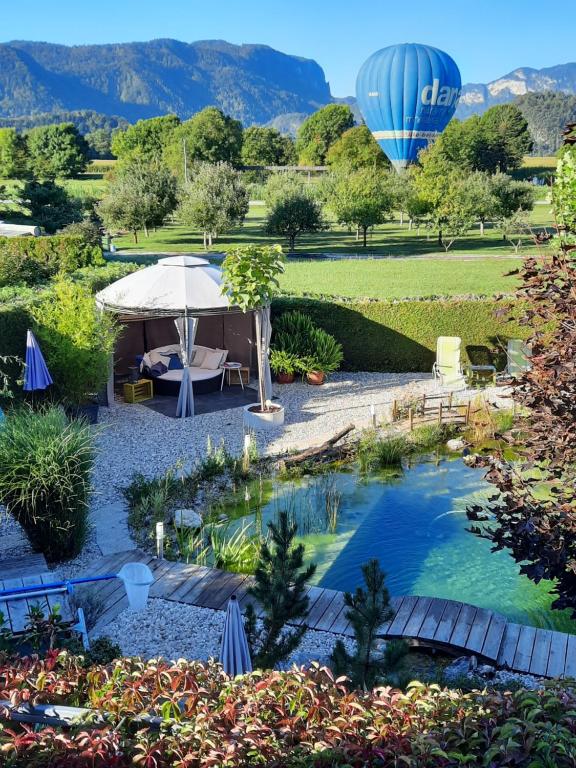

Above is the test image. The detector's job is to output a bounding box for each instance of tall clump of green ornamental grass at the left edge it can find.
[0,406,94,561]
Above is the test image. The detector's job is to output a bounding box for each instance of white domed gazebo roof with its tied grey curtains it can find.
[96,254,270,416]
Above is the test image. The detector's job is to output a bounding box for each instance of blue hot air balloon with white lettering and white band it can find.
[356,43,462,171]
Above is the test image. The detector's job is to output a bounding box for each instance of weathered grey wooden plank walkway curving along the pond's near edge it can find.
[91,551,576,677]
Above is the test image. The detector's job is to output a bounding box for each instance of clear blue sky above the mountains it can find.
[0,0,576,96]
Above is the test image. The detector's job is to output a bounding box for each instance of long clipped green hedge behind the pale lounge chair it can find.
[272,296,529,373]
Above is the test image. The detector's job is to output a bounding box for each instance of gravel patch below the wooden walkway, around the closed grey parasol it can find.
[94,599,353,666]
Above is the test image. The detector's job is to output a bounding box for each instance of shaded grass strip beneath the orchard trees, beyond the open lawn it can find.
[114,204,551,257]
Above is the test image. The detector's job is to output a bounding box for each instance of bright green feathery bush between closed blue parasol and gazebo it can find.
[30,280,118,405]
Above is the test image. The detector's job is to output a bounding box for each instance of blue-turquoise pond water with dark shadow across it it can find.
[223,457,576,633]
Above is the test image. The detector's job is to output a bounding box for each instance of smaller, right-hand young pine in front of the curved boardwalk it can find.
[331,560,408,690]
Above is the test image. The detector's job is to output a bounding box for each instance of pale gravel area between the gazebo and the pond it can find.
[94,373,510,507]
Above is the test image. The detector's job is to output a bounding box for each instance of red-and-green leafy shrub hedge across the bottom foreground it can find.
[0,652,576,768]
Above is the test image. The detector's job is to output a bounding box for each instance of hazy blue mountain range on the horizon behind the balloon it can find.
[0,39,576,133]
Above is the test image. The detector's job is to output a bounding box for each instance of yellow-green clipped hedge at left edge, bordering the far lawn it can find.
[0,235,104,287]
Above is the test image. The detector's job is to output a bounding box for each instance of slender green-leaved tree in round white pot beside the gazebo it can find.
[222,245,284,429]
